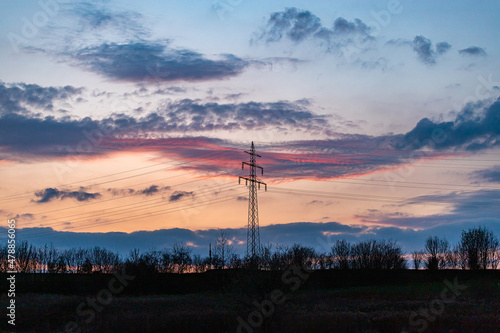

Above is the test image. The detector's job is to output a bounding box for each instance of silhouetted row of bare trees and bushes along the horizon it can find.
[0,227,500,273]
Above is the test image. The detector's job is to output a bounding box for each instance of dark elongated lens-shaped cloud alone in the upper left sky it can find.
[72,41,248,82]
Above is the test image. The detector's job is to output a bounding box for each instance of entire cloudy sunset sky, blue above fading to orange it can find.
[0,0,500,255]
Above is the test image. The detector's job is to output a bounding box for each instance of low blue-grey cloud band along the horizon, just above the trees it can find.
[5,220,500,256]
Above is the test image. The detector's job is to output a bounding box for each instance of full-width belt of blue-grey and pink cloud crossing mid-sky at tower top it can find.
[0,89,500,183]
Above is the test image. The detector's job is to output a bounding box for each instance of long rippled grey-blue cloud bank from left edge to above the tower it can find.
[0,99,329,157]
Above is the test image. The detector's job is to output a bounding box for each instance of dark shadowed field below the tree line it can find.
[0,270,500,333]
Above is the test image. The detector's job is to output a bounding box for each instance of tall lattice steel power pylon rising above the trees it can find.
[238,141,267,261]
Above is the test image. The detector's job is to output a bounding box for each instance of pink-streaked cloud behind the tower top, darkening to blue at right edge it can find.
[163,100,500,182]
